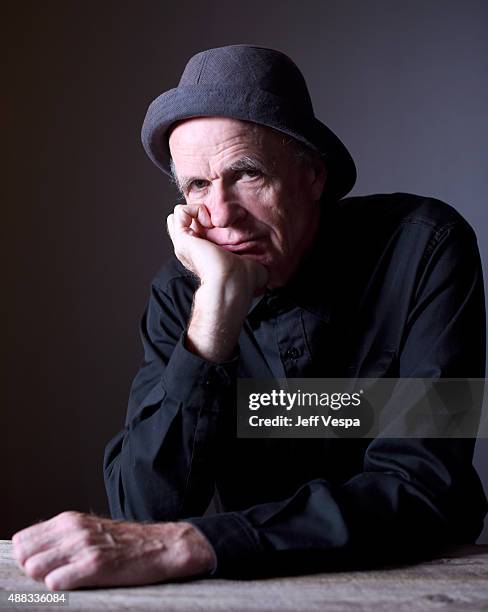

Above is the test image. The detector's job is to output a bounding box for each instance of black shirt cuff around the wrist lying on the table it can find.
[185,512,263,577]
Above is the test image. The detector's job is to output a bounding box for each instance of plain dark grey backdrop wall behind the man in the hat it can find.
[0,0,488,541]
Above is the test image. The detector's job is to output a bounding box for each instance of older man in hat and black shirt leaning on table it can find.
[14,45,486,589]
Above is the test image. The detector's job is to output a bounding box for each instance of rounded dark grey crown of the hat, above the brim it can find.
[179,45,313,116]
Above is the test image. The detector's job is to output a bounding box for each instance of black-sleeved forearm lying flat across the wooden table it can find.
[189,439,484,577]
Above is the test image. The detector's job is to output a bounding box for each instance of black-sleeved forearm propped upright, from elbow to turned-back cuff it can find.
[104,337,237,521]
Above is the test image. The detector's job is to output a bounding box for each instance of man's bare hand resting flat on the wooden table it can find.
[12,511,215,590]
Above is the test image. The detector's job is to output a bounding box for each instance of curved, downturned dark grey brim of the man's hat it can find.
[141,85,356,201]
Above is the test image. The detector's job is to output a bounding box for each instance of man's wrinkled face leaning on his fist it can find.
[169,117,325,287]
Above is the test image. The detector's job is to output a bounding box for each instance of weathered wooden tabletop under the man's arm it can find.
[0,540,488,612]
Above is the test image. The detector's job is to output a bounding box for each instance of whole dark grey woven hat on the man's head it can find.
[142,45,356,200]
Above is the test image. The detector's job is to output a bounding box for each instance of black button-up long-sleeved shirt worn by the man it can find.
[104,194,487,575]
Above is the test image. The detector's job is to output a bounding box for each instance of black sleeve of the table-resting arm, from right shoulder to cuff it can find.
[187,218,486,575]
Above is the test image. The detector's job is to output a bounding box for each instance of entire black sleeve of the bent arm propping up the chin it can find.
[104,274,237,520]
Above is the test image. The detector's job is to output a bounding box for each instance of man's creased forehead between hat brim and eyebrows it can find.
[169,117,286,158]
